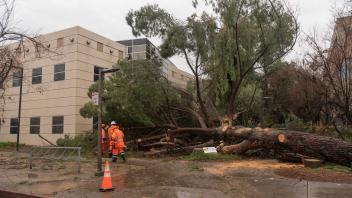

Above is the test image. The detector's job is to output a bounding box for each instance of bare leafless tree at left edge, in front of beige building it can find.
[0,0,50,122]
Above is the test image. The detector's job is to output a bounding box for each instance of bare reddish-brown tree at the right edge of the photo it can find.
[305,6,352,137]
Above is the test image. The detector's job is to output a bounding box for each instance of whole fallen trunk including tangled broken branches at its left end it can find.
[129,127,352,166]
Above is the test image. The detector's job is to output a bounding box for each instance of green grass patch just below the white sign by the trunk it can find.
[180,152,241,161]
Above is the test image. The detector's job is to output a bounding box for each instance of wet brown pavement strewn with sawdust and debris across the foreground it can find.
[0,151,352,198]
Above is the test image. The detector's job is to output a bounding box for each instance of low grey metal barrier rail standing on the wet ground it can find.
[29,146,81,173]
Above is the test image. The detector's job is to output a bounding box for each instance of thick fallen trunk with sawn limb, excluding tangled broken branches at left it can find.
[169,127,352,166]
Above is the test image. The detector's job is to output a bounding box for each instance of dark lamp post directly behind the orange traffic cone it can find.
[95,68,119,176]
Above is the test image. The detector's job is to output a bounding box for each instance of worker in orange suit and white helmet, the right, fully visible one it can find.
[110,122,126,162]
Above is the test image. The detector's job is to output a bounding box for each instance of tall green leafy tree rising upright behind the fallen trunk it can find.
[126,0,298,126]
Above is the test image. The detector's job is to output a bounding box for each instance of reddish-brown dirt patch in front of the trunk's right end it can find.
[275,167,352,184]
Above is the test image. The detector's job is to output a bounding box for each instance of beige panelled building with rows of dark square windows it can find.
[0,26,192,145]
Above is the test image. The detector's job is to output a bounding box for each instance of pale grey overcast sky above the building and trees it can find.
[15,0,343,71]
